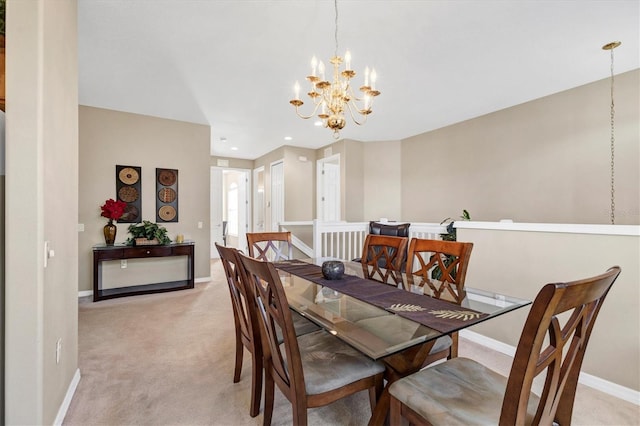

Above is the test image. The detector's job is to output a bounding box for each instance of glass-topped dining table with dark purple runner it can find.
[275,258,531,360]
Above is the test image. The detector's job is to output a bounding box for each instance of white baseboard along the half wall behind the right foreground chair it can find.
[460,330,640,405]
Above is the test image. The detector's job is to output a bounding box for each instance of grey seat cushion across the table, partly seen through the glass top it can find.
[357,315,453,354]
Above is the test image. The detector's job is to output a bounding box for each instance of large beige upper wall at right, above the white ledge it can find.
[401,70,640,224]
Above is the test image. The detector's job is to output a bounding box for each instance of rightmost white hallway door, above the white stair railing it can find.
[316,154,340,221]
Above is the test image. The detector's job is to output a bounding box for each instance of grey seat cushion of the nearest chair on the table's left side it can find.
[281,330,385,395]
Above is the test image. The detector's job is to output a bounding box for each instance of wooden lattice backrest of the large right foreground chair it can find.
[500,266,620,425]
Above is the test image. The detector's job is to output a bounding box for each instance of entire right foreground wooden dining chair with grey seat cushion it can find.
[389,266,620,426]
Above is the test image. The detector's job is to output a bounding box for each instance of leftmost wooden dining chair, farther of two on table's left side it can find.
[216,243,263,417]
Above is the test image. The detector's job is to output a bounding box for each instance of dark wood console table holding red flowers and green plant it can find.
[93,242,194,302]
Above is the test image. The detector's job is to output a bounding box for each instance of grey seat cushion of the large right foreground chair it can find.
[389,357,539,425]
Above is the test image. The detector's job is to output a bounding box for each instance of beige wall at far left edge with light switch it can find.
[4,0,78,425]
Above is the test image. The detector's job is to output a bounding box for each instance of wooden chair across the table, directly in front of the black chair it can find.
[360,234,408,285]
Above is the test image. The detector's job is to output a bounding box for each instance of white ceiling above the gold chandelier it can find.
[78,0,640,159]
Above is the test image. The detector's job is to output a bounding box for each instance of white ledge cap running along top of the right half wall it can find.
[454,220,640,237]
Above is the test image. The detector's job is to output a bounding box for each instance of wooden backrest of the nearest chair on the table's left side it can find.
[240,254,306,399]
